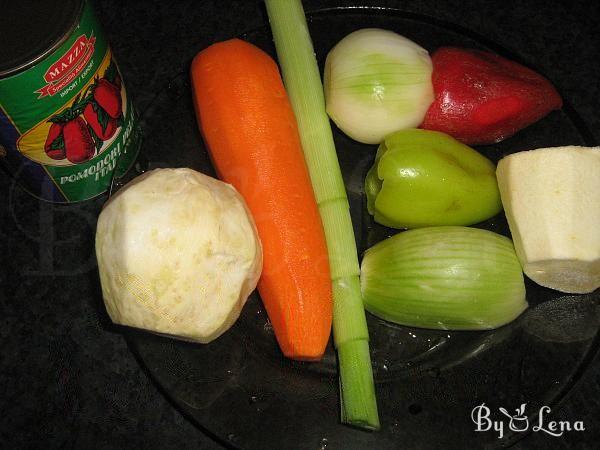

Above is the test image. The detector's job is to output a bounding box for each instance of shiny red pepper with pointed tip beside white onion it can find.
[421,47,562,145]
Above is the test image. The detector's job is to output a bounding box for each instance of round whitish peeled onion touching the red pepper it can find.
[324,28,434,144]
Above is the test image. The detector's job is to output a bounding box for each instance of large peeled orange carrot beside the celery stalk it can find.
[191,39,332,360]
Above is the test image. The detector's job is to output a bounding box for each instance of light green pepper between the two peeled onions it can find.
[365,129,502,228]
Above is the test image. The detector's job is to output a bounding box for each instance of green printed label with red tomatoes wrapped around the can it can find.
[0,4,141,202]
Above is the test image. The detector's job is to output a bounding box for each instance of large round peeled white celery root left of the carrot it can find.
[96,169,262,343]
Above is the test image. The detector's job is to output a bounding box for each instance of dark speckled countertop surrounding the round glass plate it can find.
[0,0,600,449]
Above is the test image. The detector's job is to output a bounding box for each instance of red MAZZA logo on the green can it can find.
[35,34,96,98]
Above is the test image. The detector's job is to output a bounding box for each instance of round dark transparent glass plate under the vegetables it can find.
[121,8,600,449]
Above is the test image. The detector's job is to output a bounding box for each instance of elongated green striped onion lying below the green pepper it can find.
[360,226,527,330]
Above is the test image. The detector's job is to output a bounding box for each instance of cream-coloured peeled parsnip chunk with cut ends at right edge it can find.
[496,146,600,293]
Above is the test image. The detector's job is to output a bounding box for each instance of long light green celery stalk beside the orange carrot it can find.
[265,0,379,430]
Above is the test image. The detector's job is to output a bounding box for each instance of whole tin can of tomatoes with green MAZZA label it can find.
[0,0,141,203]
